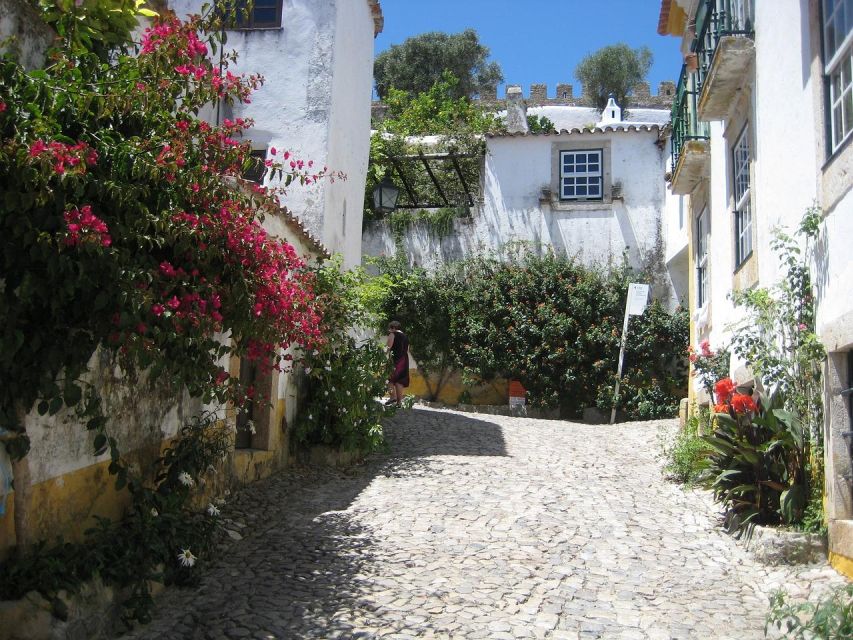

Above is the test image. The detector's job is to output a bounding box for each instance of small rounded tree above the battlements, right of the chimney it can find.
[575,43,653,109]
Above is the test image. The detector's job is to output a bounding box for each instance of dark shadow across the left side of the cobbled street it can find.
[125,409,508,640]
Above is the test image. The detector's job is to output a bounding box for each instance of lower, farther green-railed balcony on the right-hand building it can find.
[672,65,710,195]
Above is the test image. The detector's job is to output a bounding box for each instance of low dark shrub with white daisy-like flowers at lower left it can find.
[0,413,231,623]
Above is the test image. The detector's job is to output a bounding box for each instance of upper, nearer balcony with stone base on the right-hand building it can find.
[693,0,755,120]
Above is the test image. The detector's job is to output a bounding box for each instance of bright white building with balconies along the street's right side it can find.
[658,0,853,577]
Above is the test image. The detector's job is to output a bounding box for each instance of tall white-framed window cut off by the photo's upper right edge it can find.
[823,0,853,153]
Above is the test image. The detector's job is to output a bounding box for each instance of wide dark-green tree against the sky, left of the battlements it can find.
[373,29,503,100]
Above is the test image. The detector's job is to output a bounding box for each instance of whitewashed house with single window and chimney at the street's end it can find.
[362,85,687,306]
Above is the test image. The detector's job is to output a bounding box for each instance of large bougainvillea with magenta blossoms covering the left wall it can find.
[0,2,326,457]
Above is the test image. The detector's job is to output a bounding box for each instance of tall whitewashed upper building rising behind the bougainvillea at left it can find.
[169,0,383,267]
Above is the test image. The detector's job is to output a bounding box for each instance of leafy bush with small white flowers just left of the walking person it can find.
[294,259,394,453]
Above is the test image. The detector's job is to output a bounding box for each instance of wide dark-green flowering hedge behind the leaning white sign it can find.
[382,251,688,418]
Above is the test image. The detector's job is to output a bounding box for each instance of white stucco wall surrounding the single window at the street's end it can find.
[362,130,671,299]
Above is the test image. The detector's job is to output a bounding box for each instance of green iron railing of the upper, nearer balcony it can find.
[692,0,755,91]
